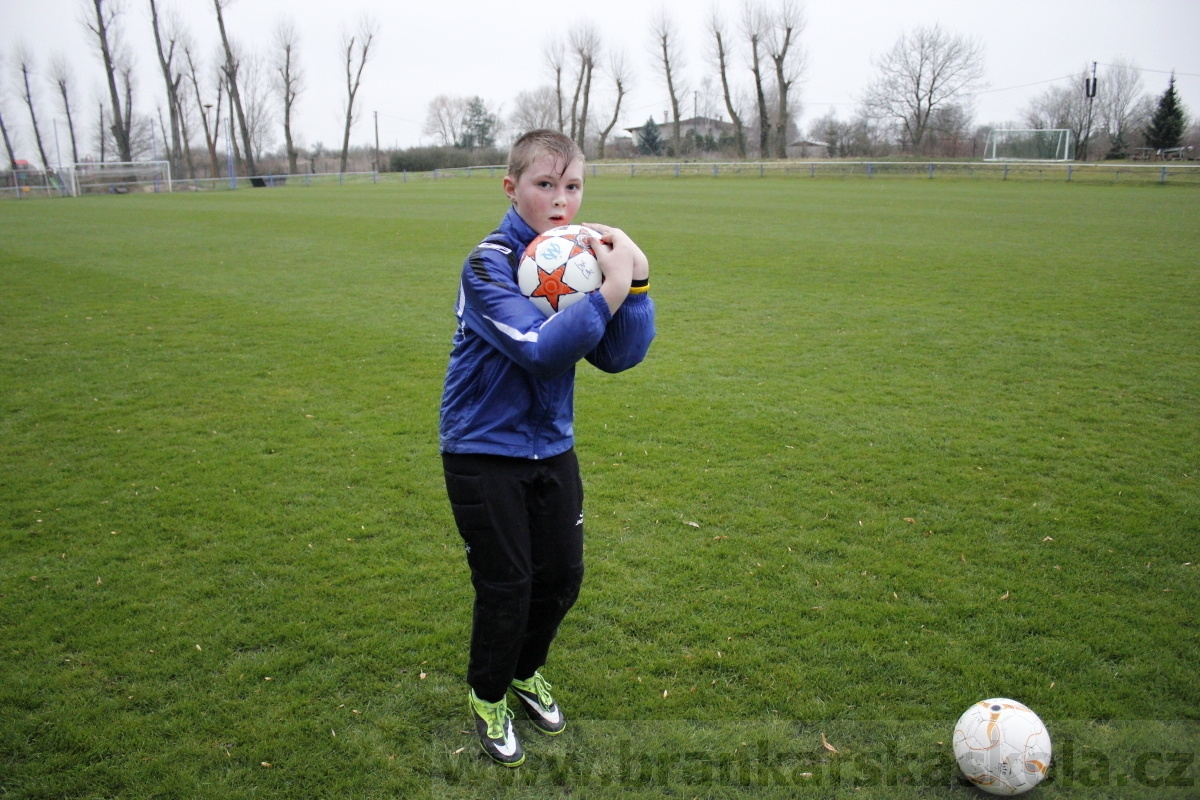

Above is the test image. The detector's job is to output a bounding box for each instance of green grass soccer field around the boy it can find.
[0,178,1200,798]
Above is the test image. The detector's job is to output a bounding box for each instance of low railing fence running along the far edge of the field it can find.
[0,160,1200,199]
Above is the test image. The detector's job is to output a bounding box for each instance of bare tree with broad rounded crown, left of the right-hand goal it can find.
[863,25,983,152]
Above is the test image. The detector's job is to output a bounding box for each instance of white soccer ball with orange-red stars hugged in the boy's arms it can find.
[517,225,604,317]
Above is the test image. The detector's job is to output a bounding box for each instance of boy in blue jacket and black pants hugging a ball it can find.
[439,131,654,766]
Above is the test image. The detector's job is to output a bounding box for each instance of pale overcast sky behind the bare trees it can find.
[0,0,1200,161]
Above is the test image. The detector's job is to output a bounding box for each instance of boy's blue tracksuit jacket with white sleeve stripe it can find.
[439,209,654,458]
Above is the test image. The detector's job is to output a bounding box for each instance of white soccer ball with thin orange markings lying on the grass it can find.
[954,698,1050,795]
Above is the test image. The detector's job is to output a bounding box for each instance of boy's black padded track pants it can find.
[442,450,583,703]
